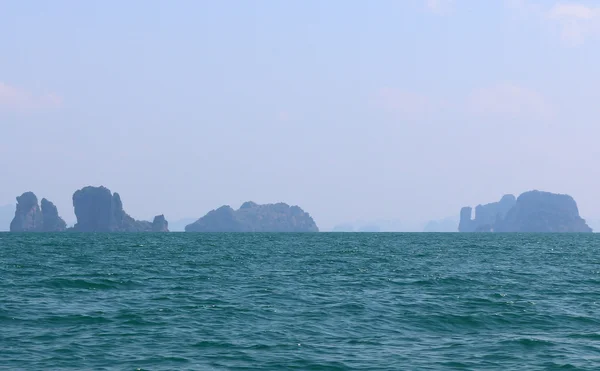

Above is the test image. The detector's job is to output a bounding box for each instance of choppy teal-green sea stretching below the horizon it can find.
[0,233,600,370]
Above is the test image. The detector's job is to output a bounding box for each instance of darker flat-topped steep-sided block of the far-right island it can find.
[496,191,592,233]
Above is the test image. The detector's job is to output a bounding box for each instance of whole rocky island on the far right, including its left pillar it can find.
[459,191,592,233]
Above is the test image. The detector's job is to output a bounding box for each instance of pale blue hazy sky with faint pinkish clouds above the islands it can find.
[0,0,600,229]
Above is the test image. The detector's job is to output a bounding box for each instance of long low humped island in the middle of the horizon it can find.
[185,201,319,232]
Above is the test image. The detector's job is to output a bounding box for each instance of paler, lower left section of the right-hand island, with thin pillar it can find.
[458,195,516,232]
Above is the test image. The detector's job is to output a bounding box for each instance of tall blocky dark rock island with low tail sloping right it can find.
[73,186,166,232]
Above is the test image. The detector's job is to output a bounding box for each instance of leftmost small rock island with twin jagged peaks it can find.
[10,192,67,232]
